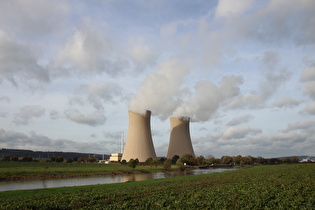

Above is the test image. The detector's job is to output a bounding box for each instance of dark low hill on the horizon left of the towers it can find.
[0,148,110,160]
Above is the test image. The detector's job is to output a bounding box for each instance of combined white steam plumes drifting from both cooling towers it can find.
[129,59,243,122]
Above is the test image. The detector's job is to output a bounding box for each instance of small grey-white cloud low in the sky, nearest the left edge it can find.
[13,105,45,125]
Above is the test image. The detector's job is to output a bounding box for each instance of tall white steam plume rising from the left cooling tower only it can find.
[129,59,189,119]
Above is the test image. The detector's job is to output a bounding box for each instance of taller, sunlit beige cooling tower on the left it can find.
[122,110,156,162]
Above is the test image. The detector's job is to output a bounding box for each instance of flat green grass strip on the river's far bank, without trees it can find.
[0,162,167,181]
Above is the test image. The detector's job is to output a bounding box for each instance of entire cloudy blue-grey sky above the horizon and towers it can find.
[0,0,315,157]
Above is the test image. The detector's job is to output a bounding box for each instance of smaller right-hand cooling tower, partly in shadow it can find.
[166,117,195,159]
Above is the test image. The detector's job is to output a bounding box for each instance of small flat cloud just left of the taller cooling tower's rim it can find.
[65,110,106,127]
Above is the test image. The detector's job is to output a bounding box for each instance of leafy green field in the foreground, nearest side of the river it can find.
[0,164,315,209]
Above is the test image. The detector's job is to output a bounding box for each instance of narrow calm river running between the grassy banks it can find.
[0,168,237,191]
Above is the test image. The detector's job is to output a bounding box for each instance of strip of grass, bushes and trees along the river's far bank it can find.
[0,154,298,181]
